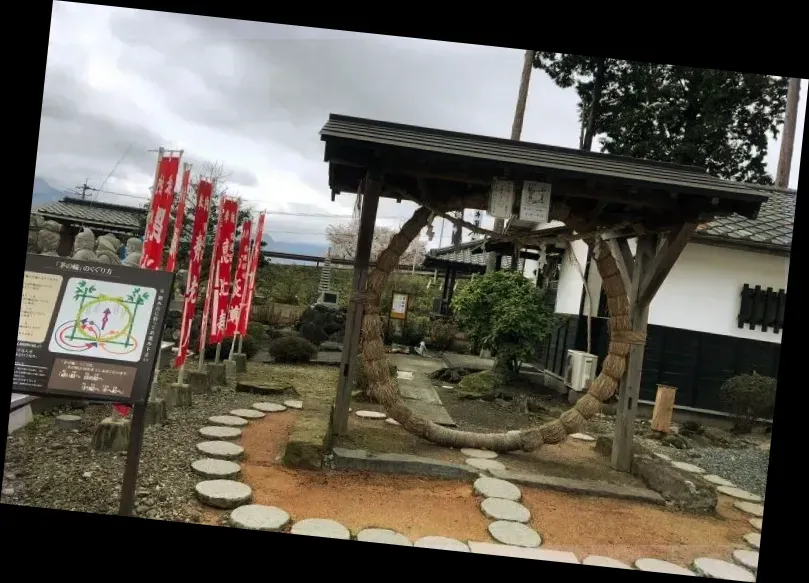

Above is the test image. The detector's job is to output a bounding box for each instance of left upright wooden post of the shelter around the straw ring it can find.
[332,172,382,435]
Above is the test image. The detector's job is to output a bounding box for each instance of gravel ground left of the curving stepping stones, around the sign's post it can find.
[0,374,278,522]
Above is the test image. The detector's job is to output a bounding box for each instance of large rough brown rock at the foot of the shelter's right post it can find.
[632,455,717,514]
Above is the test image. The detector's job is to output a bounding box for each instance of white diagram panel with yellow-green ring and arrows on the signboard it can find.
[48,278,157,362]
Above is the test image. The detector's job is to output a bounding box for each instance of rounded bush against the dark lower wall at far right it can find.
[719,371,777,433]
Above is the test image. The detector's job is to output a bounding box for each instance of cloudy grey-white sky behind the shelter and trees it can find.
[37,2,807,247]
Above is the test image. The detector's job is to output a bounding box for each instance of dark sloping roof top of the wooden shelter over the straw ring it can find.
[320,114,762,208]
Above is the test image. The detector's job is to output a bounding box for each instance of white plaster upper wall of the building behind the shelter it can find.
[556,240,789,344]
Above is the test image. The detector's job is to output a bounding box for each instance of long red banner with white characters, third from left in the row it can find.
[174,180,213,367]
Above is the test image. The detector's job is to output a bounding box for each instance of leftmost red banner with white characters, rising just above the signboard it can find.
[140,155,180,269]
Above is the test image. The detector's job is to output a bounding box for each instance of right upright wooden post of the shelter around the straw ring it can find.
[610,235,657,472]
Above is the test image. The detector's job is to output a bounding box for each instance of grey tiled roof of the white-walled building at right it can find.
[694,189,797,250]
